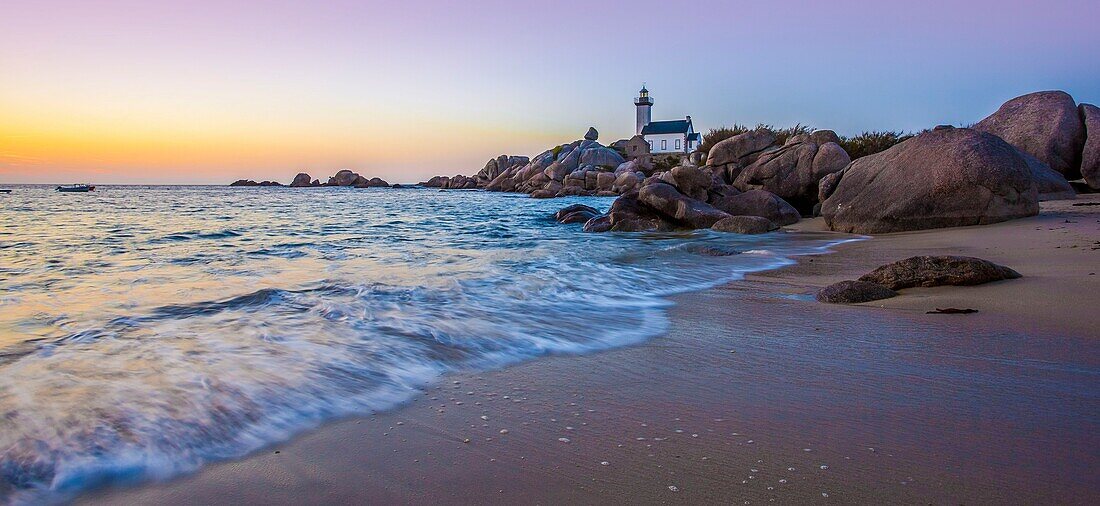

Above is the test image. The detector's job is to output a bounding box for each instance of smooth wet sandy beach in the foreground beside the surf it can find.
[81,196,1100,504]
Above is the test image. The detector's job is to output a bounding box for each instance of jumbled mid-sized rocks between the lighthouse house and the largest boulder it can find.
[558,129,850,233]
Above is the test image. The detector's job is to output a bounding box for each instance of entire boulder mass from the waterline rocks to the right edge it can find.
[585,91,1100,233]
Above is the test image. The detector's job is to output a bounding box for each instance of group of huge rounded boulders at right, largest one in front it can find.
[818,91,1100,233]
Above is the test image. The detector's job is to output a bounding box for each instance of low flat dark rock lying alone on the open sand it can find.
[859,256,1020,290]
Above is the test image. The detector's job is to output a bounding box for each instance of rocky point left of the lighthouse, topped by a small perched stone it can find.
[420,128,649,198]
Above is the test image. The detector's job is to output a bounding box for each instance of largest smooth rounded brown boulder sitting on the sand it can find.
[821,127,1038,233]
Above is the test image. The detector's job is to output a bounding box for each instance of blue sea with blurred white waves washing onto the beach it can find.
[0,187,836,503]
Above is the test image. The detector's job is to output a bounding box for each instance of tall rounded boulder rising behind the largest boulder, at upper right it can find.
[974,91,1085,179]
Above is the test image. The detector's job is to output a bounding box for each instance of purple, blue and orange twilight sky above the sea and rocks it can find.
[0,0,1100,185]
